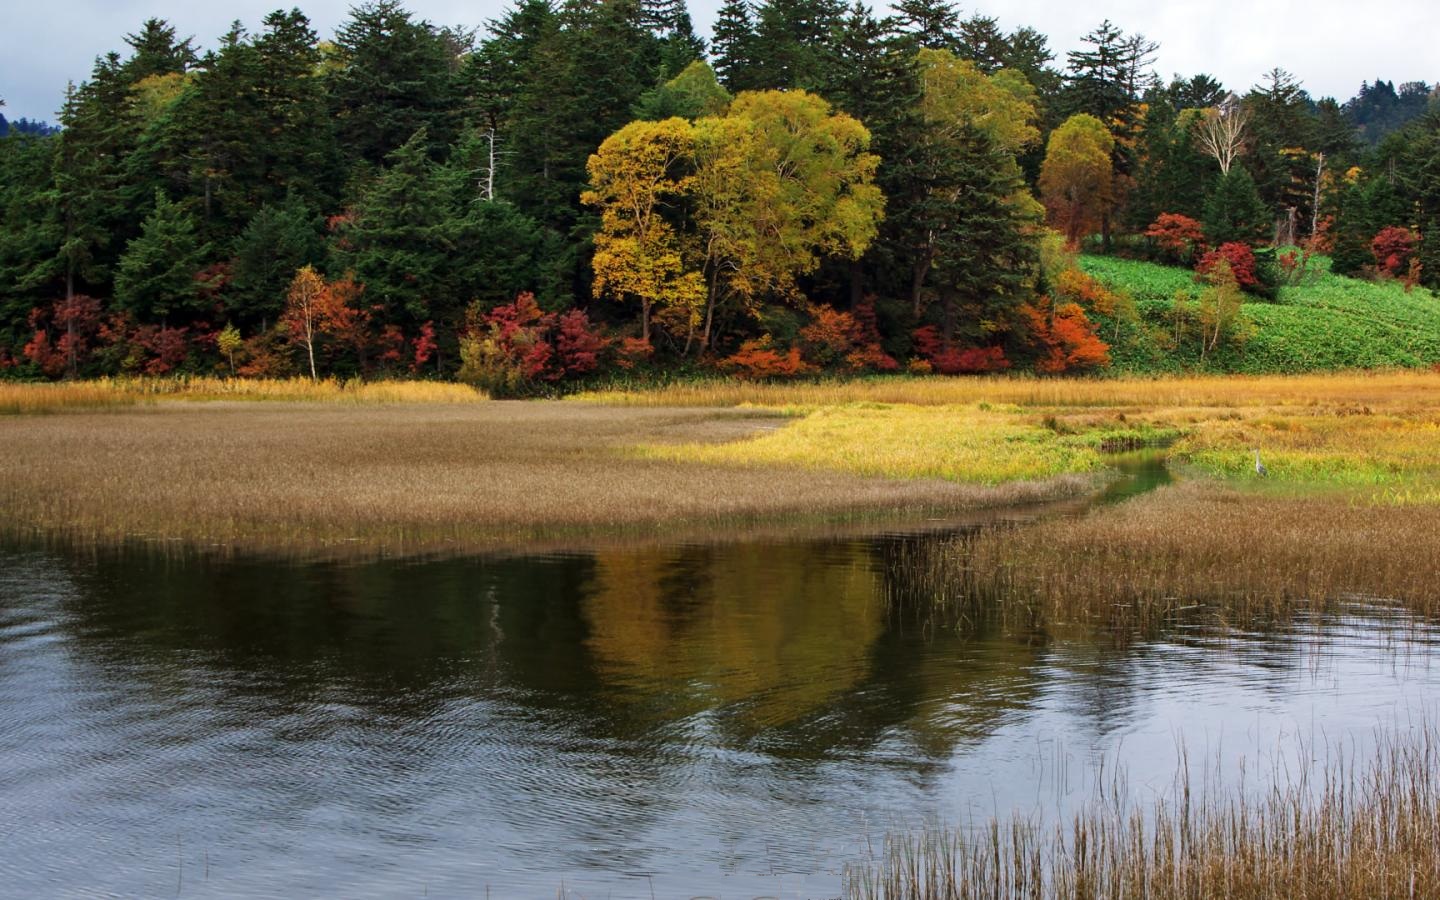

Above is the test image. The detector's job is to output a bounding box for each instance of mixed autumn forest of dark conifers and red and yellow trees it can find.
[0,0,1440,396]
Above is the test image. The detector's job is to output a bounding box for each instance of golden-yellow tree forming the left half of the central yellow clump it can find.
[580,118,706,344]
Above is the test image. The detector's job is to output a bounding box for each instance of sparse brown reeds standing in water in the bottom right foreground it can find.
[845,726,1440,900]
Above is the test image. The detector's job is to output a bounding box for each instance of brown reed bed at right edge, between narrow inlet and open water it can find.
[891,481,1440,636]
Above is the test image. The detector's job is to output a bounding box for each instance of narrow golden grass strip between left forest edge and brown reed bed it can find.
[0,377,485,415]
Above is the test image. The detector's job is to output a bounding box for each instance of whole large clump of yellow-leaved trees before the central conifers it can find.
[582,91,884,353]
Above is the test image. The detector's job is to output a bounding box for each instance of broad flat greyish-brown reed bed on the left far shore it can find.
[0,402,1087,552]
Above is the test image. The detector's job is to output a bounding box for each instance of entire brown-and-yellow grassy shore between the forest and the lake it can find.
[8,372,1440,557]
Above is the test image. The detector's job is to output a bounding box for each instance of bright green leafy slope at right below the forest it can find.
[1080,256,1440,374]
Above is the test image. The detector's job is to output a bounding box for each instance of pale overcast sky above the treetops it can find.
[0,0,1440,121]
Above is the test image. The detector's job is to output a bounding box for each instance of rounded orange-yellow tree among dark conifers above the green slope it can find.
[1040,112,1115,246]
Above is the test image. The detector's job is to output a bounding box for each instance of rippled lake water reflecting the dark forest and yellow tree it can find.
[0,515,1440,897]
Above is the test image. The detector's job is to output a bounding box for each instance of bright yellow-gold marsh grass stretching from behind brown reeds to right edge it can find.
[596,372,1440,492]
